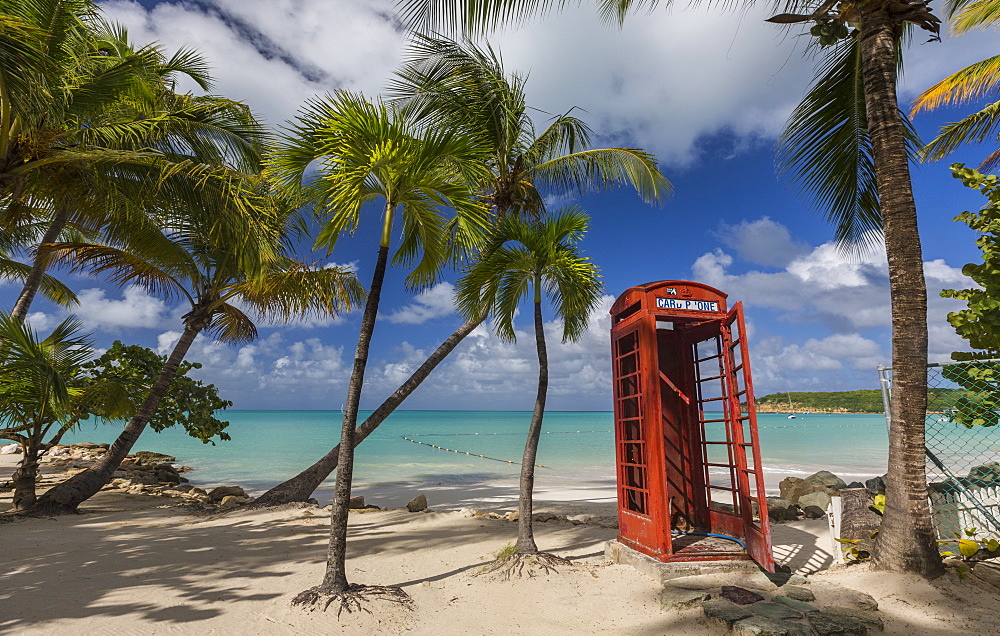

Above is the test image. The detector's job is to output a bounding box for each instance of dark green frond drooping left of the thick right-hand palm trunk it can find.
[778,39,920,249]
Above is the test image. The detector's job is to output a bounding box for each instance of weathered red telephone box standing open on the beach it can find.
[611,281,774,572]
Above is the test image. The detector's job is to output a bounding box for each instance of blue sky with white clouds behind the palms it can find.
[0,0,995,410]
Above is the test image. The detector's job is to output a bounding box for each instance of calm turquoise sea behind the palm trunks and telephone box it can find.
[56,411,1000,498]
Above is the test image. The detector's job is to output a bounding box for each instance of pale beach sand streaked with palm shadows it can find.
[0,456,1000,636]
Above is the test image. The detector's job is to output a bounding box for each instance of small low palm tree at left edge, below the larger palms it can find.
[0,314,129,511]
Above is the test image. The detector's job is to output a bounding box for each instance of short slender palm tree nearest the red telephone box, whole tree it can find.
[457,208,604,567]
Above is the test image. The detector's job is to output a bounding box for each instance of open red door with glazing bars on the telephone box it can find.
[723,302,774,572]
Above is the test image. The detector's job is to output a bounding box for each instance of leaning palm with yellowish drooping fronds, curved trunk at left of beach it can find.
[28,176,364,513]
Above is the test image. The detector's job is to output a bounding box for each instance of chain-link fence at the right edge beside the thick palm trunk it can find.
[879,360,1000,540]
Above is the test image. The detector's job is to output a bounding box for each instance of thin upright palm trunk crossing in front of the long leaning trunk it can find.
[318,242,391,594]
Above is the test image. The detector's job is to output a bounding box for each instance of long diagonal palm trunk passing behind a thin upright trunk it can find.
[253,316,486,508]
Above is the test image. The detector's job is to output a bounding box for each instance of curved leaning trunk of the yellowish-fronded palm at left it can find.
[31,316,207,514]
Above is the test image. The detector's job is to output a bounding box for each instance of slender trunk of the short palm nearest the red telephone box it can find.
[517,292,549,554]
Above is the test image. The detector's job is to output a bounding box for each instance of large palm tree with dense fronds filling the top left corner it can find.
[0,0,264,320]
